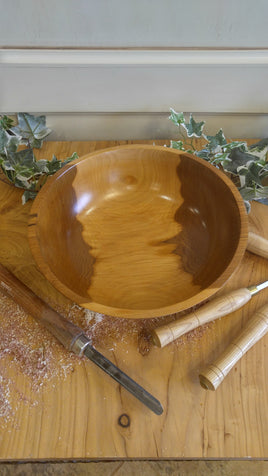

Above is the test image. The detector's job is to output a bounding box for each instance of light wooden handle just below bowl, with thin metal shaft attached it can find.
[153,288,252,347]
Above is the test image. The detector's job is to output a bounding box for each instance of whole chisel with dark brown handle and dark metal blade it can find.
[0,264,163,415]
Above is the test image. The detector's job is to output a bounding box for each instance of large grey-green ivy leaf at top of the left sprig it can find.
[11,113,51,149]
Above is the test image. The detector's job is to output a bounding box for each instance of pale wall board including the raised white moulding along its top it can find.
[0,49,268,114]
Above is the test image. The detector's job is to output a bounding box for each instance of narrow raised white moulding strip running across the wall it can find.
[0,48,268,67]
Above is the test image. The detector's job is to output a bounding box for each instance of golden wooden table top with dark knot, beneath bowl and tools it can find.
[0,141,268,460]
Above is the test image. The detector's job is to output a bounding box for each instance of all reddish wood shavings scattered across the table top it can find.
[0,293,208,422]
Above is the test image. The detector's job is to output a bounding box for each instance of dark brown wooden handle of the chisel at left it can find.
[0,264,85,350]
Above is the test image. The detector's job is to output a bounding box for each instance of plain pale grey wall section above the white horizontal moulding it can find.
[0,0,268,48]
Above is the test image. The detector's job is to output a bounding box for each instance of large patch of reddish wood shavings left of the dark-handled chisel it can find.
[0,293,79,423]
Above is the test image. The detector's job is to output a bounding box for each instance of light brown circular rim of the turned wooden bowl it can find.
[28,144,248,319]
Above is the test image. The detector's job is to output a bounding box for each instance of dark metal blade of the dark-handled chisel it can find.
[83,344,163,415]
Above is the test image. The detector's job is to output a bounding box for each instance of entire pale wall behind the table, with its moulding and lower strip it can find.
[0,0,268,139]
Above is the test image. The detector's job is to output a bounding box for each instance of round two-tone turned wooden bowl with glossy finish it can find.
[29,145,247,318]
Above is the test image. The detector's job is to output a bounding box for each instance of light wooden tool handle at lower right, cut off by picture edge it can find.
[199,304,268,390]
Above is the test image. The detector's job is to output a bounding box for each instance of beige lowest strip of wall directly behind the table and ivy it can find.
[27,111,268,140]
